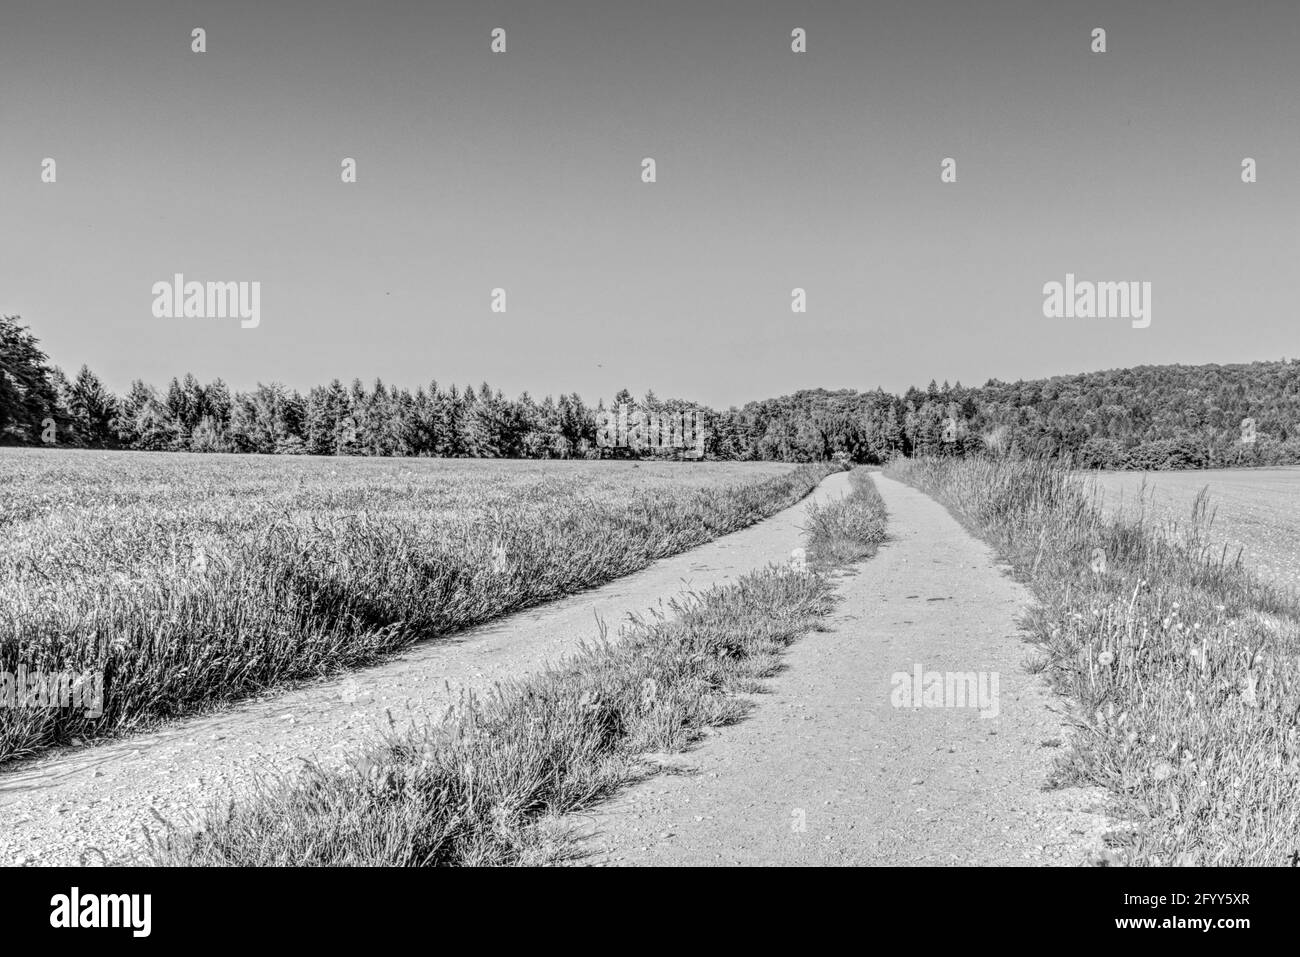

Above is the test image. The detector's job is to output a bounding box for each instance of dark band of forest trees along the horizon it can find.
[0,317,1300,469]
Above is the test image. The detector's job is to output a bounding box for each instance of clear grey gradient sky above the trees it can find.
[0,0,1300,406]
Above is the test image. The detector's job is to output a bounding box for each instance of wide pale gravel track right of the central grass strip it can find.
[573,475,1105,865]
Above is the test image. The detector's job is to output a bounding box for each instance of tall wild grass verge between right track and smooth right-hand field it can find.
[889,459,1300,865]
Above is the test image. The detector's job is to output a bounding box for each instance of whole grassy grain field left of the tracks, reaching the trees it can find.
[0,450,833,763]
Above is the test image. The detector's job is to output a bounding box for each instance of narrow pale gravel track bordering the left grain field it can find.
[0,473,849,866]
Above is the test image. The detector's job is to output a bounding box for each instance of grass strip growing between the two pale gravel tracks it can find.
[152,472,885,866]
